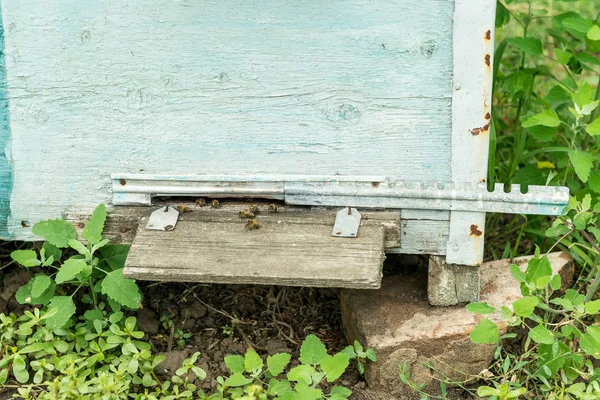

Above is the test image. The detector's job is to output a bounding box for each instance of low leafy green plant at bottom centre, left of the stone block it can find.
[210,335,375,400]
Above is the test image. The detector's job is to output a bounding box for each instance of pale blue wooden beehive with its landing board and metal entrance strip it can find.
[0,0,564,304]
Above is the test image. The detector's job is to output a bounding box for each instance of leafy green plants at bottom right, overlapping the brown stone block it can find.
[467,217,600,399]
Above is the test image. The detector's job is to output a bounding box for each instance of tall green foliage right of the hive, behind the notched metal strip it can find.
[487,0,600,264]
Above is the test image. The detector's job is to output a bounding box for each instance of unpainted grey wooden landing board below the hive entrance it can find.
[125,206,392,289]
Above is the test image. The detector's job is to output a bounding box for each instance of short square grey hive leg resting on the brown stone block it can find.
[427,256,480,306]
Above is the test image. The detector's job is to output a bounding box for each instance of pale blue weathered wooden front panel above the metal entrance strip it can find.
[2,0,454,238]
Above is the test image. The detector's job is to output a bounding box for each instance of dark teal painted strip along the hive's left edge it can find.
[0,3,13,240]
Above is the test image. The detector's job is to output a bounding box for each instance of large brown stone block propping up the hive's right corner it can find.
[341,252,574,399]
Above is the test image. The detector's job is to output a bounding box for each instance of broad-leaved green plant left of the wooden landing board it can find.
[11,204,141,329]
